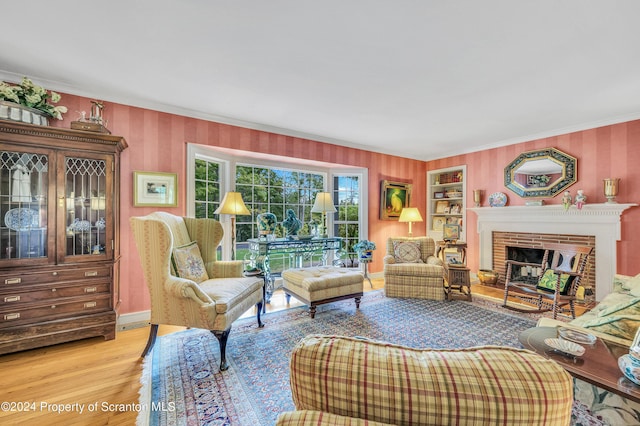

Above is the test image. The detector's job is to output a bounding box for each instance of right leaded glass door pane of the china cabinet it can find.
[64,157,111,257]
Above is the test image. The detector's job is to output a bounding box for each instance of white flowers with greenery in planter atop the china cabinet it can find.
[0,77,67,122]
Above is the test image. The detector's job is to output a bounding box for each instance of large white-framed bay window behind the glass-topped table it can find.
[187,144,368,266]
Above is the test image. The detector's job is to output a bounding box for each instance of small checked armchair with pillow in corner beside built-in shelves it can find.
[382,237,445,300]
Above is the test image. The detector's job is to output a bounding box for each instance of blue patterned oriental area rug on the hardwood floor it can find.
[138,291,597,426]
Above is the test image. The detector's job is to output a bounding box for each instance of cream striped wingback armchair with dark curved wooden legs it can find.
[130,212,263,371]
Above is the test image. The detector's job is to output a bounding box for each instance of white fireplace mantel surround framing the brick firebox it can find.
[468,203,637,300]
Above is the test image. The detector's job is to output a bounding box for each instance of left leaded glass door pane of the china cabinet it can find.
[0,149,50,260]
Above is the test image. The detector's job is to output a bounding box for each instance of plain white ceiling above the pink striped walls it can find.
[0,0,640,160]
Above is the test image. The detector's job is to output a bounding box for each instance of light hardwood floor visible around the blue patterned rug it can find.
[0,279,588,425]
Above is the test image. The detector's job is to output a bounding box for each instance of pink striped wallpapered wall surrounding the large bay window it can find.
[52,95,426,313]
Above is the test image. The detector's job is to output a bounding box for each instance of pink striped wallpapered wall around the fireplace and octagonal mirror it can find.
[427,120,640,275]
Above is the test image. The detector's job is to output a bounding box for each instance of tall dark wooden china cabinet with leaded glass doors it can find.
[0,120,127,354]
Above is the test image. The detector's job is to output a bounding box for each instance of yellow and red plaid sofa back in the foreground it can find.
[276,335,573,426]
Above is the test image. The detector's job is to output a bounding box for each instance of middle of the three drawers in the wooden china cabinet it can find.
[0,281,111,309]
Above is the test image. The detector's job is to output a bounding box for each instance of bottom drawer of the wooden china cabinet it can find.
[0,294,111,328]
